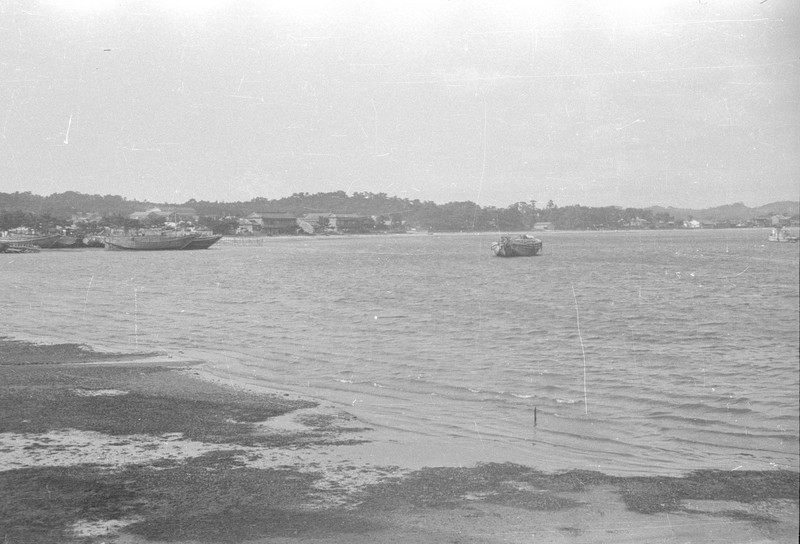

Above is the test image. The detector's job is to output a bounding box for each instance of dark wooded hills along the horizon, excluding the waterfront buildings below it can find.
[0,191,800,231]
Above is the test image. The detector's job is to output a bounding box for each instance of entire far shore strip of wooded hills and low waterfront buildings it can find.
[0,191,800,236]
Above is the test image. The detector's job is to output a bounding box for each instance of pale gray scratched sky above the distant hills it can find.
[0,0,800,208]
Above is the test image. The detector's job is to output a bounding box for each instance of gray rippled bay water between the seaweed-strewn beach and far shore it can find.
[0,230,800,472]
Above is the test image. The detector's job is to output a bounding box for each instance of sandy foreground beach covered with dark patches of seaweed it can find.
[0,338,798,544]
